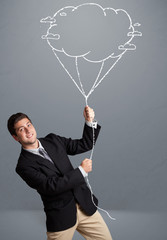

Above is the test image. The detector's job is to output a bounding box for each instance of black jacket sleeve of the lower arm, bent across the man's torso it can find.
[16,166,85,195]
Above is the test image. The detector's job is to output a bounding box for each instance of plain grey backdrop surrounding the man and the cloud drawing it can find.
[0,0,167,240]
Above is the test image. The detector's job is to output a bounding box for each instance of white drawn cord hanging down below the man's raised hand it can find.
[85,120,116,220]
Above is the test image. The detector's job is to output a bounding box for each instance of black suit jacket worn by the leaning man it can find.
[16,124,100,232]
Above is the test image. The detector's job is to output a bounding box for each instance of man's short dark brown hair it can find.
[7,112,31,136]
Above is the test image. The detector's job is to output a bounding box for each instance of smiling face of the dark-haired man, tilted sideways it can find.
[13,118,38,149]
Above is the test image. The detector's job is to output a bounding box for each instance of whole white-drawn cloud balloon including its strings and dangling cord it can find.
[40,3,142,219]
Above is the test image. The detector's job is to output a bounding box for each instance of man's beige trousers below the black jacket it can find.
[47,204,112,240]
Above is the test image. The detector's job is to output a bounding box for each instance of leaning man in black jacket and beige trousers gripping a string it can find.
[8,106,112,240]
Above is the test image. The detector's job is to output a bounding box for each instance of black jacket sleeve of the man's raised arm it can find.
[52,124,101,155]
